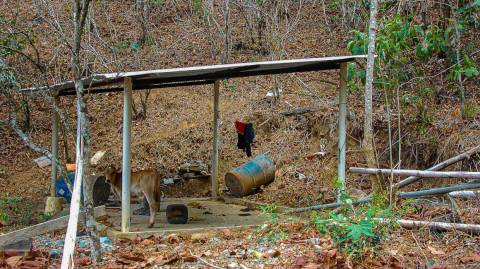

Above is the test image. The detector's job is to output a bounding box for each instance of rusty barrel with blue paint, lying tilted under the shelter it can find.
[225,155,275,197]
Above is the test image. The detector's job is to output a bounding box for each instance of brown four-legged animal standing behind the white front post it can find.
[105,166,161,228]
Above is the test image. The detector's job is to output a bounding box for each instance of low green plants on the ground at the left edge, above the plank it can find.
[0,192,35,226]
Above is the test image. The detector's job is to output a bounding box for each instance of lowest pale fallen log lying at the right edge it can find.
[375,218,480,234]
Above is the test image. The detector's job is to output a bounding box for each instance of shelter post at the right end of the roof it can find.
[337,63,347,202]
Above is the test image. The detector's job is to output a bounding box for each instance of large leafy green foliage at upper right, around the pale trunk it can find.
[347,8,479,129]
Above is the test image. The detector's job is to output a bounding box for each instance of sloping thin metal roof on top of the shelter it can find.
[23,55,367,95]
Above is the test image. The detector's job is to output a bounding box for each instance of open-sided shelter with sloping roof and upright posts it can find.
[23,55,367,232]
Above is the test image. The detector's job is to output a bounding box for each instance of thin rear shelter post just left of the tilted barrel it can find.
[212,80,220,201]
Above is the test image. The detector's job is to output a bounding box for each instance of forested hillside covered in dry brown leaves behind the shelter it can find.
[0,0,480,268]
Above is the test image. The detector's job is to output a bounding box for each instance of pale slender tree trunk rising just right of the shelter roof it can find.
[363,0,385,196]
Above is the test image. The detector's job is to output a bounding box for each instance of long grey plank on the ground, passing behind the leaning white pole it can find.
[0,205,107,246]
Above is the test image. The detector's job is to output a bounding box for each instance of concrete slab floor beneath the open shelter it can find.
[103,198,289,233]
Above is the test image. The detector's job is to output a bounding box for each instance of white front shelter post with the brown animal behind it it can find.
[122,77,132,233]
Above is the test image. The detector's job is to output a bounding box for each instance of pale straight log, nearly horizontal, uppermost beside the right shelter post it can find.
[350,167,480,179]
